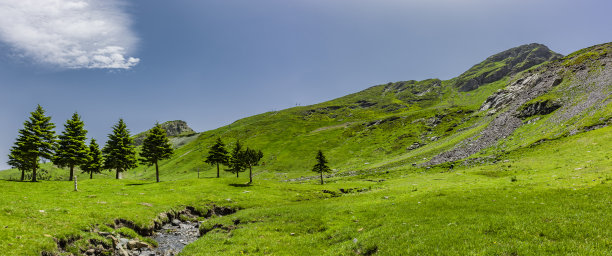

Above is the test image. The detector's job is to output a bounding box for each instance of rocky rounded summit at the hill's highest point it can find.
[455,43,562,92]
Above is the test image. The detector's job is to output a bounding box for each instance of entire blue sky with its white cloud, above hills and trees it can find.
[0,0,612,169]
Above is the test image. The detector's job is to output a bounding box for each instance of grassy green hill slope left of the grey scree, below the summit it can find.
[0,44,592,181]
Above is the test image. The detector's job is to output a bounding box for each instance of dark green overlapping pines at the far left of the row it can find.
[8,105,55,182]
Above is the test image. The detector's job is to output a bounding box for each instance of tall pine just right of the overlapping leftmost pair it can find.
[53,113,88,180]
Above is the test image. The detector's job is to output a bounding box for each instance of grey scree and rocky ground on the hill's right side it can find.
[425,44,612,165]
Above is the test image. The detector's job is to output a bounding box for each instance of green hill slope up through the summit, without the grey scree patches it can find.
[122,44,610,180]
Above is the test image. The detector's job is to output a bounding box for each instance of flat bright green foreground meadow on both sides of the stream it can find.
[0,127,612,255]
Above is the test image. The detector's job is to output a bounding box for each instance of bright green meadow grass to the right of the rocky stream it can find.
[184,125,612,255]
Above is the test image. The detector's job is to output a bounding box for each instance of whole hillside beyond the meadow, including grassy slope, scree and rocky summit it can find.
[122,44,612,179]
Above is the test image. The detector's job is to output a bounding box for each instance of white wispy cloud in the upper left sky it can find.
[0,0,140,69]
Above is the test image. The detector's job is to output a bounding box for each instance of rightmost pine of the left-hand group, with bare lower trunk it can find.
[140,123,173,182]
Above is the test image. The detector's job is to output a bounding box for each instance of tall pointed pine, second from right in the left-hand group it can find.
[102,119,138,179]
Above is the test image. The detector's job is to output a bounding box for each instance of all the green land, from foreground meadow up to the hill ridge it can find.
[0,43,612,255]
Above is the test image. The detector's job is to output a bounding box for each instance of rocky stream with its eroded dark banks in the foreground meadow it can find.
[41,205,236,256]
